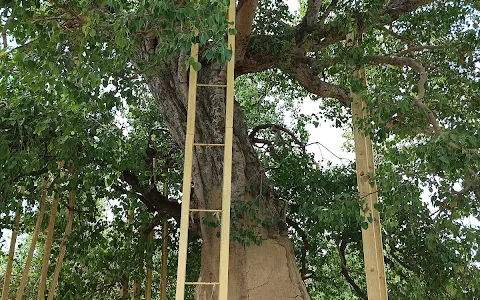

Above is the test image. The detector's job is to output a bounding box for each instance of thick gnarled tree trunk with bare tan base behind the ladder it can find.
[147,57,310,300]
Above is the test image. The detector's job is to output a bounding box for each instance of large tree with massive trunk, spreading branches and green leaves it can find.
[0,0,480,300]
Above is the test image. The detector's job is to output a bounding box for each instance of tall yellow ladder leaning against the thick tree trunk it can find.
[175,0,235,300]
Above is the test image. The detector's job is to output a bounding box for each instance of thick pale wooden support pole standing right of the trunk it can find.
[347,33,388,300]
